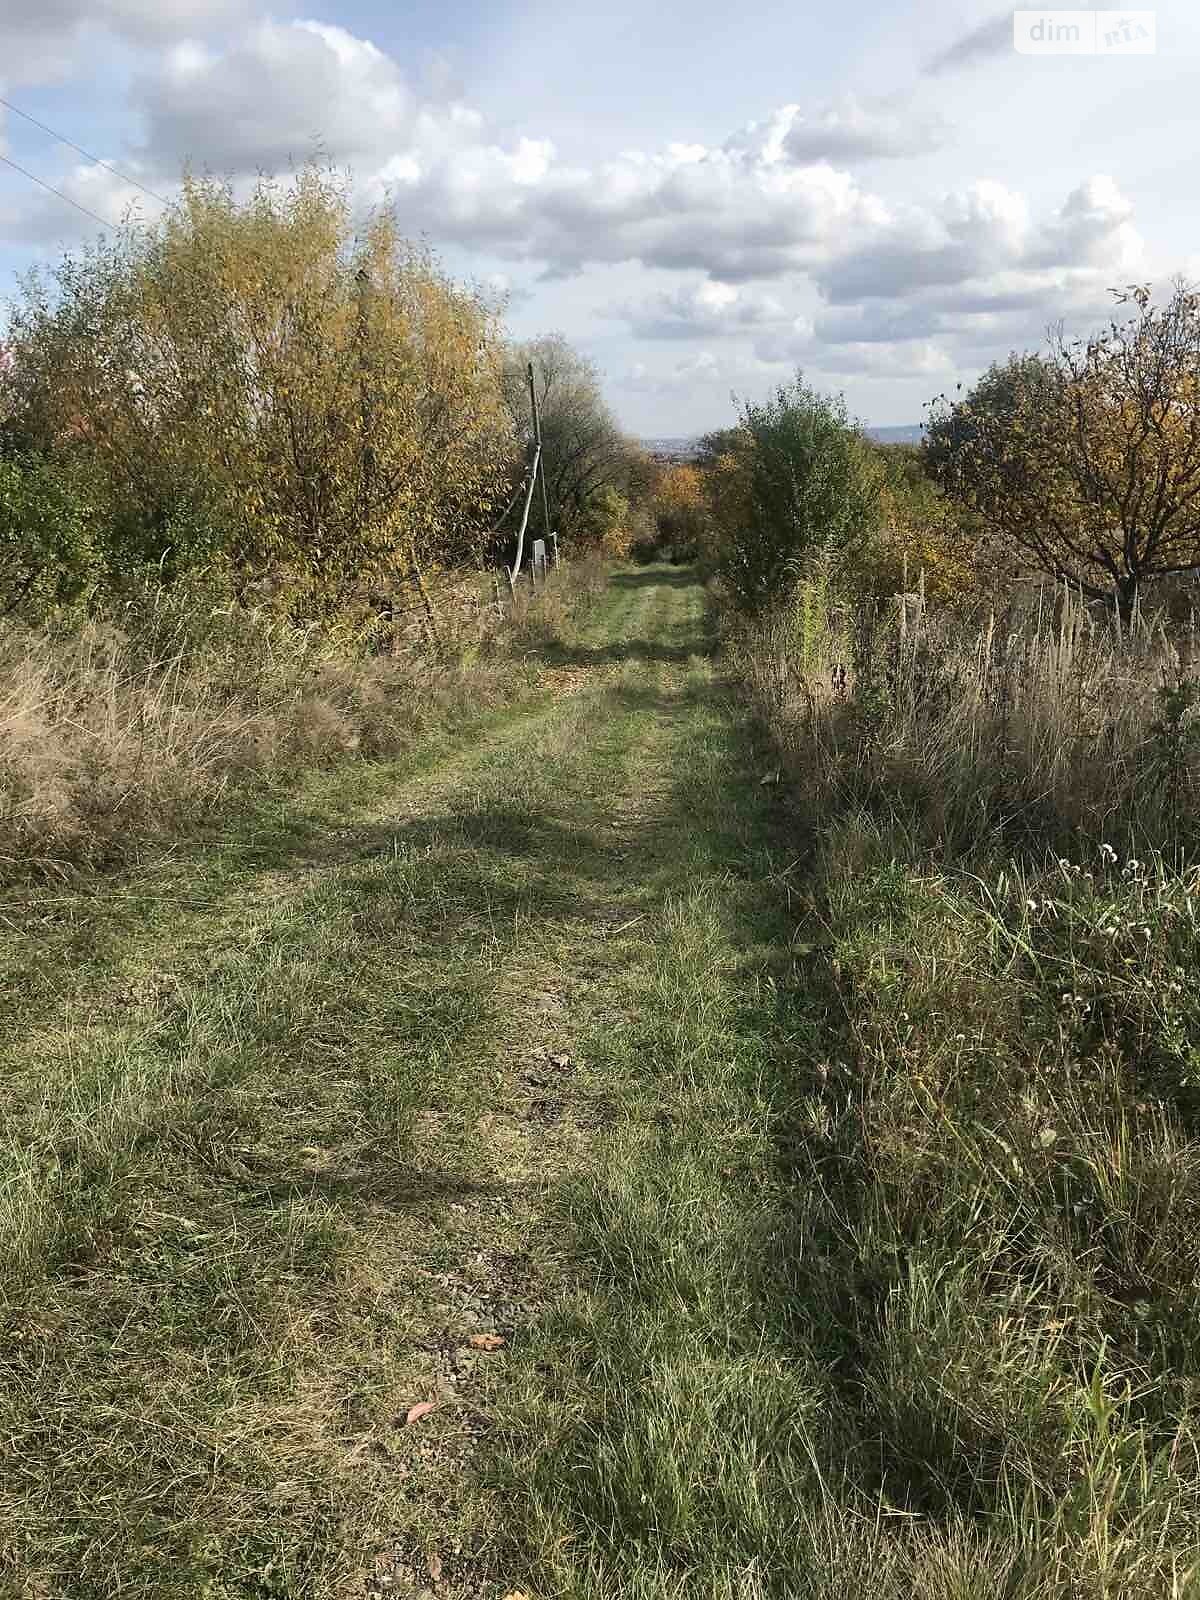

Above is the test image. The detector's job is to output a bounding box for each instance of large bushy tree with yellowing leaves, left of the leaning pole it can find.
[8,168,512,614]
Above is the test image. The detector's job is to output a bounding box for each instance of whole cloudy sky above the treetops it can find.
[0,0,1200,435]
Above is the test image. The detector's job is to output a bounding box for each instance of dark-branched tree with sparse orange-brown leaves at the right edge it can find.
[930,283,1200,613]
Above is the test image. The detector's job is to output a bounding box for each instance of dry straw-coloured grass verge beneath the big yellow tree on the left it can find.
[0,563,600,882]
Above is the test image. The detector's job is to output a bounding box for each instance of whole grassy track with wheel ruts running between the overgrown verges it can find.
[0,570,814,1600]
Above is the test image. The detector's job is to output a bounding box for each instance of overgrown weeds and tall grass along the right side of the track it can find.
[720,584,1200,1597]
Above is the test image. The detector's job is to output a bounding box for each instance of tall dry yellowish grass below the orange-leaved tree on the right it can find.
[741,586,1200,851]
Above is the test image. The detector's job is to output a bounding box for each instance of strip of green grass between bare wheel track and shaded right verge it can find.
[483,832,829,1597]
